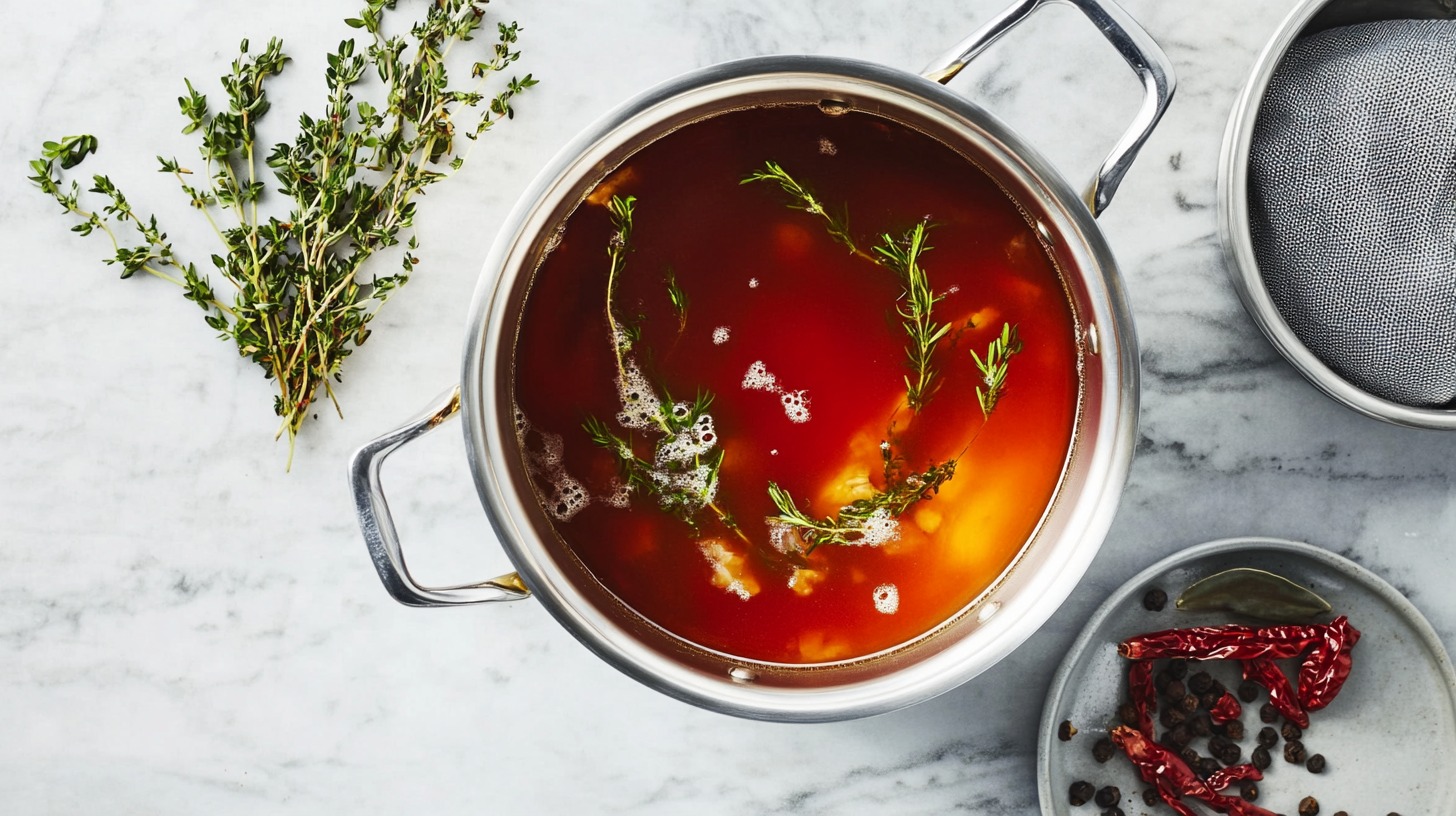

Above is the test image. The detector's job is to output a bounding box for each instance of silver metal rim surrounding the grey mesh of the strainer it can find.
[1219,0,1456,430]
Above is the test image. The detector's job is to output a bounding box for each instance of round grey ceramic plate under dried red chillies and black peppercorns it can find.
[1037,538,1456,816]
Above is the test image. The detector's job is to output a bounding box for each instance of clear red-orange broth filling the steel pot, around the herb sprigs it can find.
[514,105,1080,663]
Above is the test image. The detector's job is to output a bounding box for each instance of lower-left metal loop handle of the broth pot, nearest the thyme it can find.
[349,386,531,606]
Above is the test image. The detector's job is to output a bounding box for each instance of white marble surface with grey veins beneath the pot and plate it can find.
[0,0,1456,816]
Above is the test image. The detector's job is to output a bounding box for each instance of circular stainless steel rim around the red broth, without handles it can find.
[462,55,1139,721]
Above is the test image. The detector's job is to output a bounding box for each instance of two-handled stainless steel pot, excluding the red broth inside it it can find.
[349,0,1174,721]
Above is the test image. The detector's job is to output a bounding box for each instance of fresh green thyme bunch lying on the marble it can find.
[31,0,536,465]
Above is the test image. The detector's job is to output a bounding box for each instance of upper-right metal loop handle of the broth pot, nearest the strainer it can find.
[920,0,1178,216]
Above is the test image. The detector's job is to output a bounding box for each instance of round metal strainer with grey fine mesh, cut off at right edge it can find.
[1219,0,1456,428]
